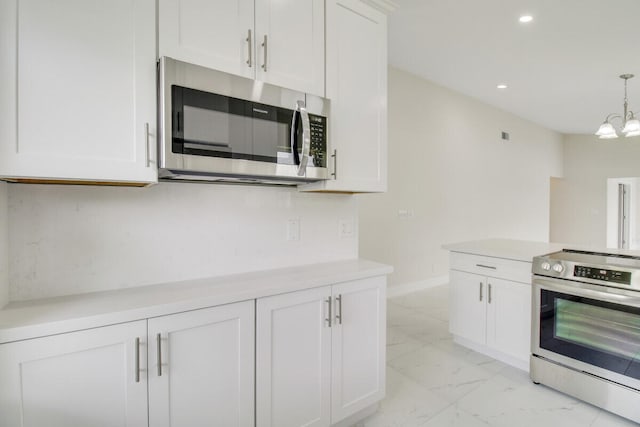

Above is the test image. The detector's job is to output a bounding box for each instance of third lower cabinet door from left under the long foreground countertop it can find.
[256,286,333,427]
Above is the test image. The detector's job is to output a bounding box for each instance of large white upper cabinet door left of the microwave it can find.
[0,0,157,183]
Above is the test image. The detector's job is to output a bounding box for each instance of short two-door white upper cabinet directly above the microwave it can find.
[158,0,324,96]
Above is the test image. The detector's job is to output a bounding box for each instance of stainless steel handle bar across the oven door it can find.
[533,278,640,307]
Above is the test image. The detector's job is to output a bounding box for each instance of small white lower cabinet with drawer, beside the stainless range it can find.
[449,256,531,369]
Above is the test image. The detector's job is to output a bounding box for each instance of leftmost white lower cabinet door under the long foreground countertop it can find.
[0,320,148,427]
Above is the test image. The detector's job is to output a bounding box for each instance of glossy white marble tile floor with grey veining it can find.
[357,285,637,427]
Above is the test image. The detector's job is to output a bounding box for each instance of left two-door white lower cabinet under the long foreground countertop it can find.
[0,300,255,427]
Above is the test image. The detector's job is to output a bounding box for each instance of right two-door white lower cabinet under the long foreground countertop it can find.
[256,277,386,427]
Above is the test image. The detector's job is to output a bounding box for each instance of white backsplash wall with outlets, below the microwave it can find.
[8,183,358,300]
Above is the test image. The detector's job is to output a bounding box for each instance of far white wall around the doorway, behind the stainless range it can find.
[551,134,640,248]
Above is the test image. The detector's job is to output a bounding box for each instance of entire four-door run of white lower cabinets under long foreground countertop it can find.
[0,276,386,427]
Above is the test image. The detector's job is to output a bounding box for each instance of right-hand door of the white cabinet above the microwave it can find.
[256,0,325,96]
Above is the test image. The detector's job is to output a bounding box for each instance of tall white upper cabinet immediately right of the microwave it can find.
[302,0,387,193]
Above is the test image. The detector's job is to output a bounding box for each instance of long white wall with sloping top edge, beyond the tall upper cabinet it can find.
[359,67,562,286]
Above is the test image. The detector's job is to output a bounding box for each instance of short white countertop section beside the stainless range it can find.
[442,239,575,262]
